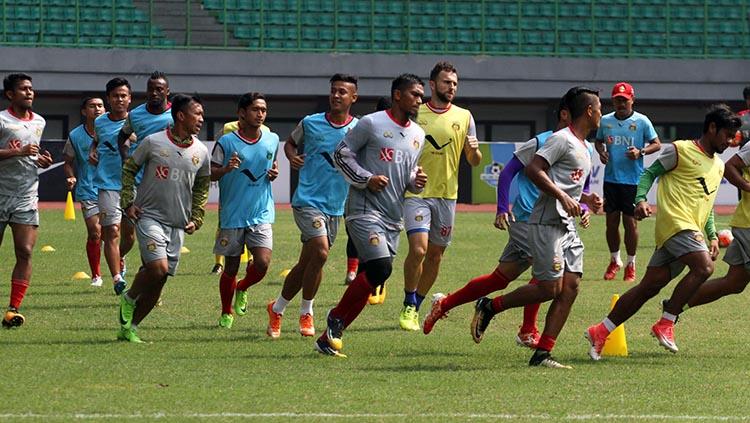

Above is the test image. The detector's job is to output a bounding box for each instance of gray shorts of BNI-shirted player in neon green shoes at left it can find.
[135,217,185,276]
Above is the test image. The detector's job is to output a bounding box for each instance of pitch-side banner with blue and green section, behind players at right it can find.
[472,142,737,205]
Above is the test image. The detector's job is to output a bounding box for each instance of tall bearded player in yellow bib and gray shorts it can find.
[399,62,482,330]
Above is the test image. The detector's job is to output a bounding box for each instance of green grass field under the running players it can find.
[0,211,750,422]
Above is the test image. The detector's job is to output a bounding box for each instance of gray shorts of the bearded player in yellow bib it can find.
[404,197,456,247]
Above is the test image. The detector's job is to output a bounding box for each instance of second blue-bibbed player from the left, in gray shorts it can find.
[89,77,131,295]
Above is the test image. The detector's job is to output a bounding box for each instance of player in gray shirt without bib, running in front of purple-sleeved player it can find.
[471,87,601,368]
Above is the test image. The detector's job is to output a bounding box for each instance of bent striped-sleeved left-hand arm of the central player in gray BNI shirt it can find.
[333,116,376,190]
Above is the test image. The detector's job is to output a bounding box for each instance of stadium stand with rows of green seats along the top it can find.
[2,0,750,58]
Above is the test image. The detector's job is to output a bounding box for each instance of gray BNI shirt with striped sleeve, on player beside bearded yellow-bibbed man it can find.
[334,110,424,230]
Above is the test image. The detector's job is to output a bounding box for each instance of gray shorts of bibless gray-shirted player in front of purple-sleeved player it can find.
[529,224,583,281]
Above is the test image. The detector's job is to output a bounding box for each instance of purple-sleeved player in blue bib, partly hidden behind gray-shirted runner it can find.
[422,92,604,348]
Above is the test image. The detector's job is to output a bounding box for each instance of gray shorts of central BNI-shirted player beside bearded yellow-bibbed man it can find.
[346,218,401,263]
